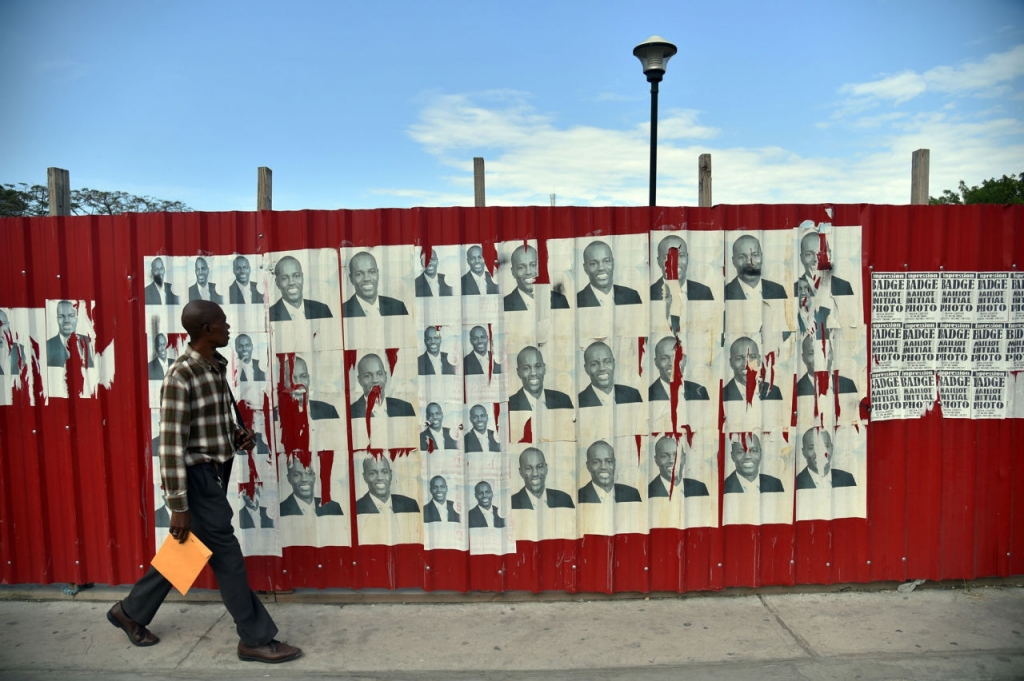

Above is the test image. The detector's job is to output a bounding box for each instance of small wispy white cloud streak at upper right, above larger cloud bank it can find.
[839,45,1024,105]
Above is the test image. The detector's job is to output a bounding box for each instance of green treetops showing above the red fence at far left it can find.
[0,182,191,217]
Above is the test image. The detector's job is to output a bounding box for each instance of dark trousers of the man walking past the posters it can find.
[121,461,278,646]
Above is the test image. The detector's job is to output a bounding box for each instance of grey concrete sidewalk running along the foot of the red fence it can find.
[0,587,1024,681]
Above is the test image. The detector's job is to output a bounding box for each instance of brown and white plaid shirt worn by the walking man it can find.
[160,345,237,511]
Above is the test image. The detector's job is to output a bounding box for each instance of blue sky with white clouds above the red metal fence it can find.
[0,0,1024,210]
